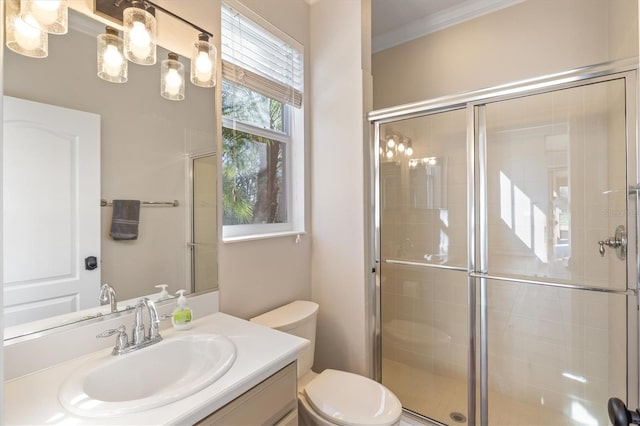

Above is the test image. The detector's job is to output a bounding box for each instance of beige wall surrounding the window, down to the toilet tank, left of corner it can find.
[218,0,311,319]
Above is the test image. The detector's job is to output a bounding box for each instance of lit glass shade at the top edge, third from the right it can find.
[122,1,156,65]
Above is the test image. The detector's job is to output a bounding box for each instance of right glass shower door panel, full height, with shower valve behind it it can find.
[476,78,636,425]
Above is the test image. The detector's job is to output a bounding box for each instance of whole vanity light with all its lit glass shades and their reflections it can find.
[3,0,218,100]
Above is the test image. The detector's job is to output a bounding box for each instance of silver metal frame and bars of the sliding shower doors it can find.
[367,58,640,426]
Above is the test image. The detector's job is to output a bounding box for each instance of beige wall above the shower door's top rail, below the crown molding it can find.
[373,0,638,109]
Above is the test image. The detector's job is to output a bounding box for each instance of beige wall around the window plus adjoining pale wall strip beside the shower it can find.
[219,0,371,373]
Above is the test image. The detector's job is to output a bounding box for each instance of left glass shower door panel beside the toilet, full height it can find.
[379,109,469,424]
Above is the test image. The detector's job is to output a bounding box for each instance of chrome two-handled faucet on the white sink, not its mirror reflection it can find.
[96,297,162,355]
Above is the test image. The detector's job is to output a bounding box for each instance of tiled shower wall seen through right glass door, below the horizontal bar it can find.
[488,281,626,424]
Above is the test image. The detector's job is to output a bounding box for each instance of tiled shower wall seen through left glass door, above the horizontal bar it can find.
[380,110,468,268]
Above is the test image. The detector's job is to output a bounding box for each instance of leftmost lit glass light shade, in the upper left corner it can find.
[6,7,49,58]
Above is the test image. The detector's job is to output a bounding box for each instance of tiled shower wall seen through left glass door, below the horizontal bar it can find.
[382,266,468,381]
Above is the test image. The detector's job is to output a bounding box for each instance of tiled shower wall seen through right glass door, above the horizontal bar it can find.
[486,80,626,289]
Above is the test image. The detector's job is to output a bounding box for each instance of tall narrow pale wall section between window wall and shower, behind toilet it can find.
[311,0,370,373]
